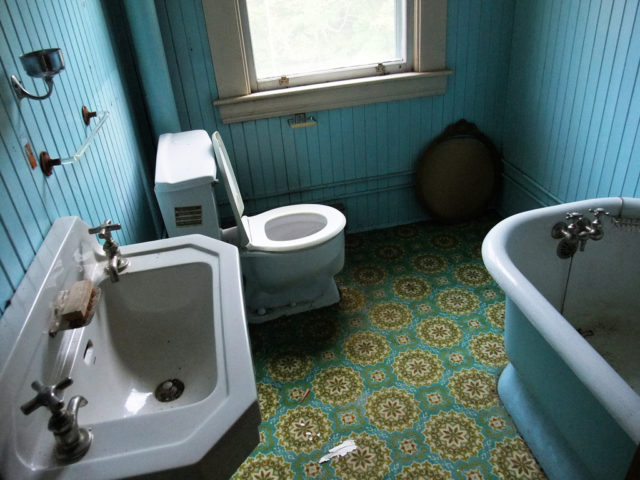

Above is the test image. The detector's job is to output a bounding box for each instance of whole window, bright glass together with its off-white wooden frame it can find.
[203,0,451,123]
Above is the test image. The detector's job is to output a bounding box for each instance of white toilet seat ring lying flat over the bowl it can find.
[242,204,346,252]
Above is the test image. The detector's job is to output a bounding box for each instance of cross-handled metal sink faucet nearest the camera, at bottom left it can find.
[20,377,93,463]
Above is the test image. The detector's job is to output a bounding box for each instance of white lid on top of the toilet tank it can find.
[155,130,216,192]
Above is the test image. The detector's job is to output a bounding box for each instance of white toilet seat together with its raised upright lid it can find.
[211,132,346,252]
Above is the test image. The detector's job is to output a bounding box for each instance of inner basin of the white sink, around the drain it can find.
[72,262,221,423]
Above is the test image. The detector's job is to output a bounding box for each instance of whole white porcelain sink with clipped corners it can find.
[0,217,260,479]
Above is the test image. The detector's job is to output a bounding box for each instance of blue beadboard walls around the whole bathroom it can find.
[10,0,640,311]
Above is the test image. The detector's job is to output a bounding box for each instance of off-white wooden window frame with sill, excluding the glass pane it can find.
[202,0,453,123]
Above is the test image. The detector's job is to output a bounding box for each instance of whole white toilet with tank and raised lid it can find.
[155,130,346,323]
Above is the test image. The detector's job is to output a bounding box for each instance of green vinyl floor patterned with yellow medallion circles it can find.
[233,217,545,480]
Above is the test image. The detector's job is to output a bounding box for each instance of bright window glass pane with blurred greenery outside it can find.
[246,0,407,82]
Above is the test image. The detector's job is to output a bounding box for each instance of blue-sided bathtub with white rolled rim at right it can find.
[482,197,640,480]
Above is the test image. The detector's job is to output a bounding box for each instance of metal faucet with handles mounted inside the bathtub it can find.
[551,208,610,258]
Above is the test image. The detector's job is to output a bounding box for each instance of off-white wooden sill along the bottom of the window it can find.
[213,70,453,123]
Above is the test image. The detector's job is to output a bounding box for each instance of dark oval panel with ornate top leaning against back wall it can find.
[416,120,500,222]
